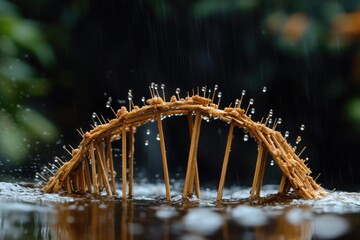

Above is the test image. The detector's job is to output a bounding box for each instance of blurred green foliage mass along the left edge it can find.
[0,0,57,163]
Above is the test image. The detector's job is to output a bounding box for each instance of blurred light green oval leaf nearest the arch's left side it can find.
[17,108,58,142]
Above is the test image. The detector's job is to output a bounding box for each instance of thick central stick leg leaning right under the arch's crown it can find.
[182,113,201,199]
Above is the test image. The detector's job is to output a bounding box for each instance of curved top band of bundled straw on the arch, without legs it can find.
[43,95,324,199]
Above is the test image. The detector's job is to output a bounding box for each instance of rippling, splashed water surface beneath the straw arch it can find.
[0,182,360,240]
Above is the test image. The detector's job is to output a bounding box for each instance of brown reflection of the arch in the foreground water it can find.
[49,201,312,240]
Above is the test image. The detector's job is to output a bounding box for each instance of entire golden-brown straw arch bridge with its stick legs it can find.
[42,94,324,201]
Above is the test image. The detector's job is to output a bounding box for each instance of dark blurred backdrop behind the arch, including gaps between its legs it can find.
[0,0,360,190]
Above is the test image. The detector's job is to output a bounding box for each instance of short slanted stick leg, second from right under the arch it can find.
[250,143,268,198]
